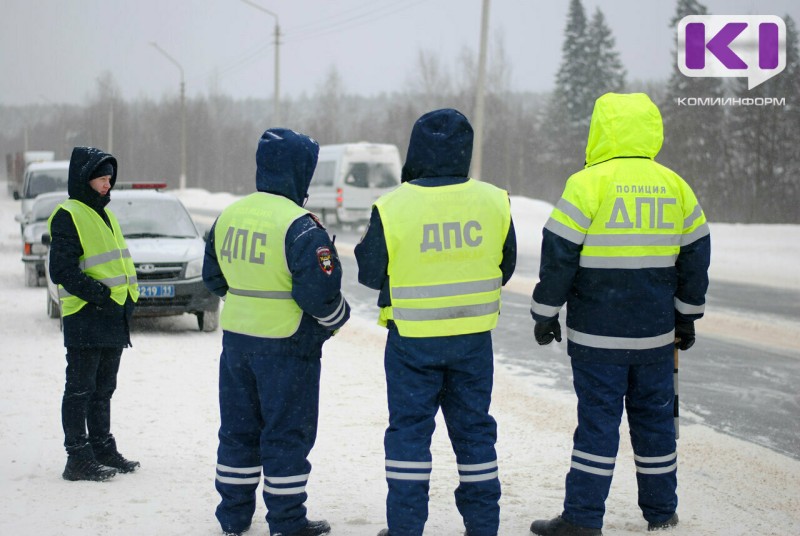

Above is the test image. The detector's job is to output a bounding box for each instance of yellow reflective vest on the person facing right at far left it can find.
[47,199,139,316]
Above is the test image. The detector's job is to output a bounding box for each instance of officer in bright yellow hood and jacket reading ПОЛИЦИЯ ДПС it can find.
[531,93,711,536]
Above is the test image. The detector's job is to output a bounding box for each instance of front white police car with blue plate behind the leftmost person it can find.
[47,182,220,331]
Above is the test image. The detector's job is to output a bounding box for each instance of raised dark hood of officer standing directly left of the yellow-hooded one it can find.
[402,108,473,182]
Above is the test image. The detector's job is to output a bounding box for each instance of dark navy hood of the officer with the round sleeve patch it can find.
[256,128,319,206]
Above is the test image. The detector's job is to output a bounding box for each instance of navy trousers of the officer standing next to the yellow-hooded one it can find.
[384,329,500,536]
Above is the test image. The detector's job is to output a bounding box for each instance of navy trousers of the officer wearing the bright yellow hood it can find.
[562,359,678,528]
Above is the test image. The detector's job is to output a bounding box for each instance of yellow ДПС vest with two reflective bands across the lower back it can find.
[375,179,511,337]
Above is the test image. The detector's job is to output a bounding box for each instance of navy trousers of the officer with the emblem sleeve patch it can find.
[216,344,321,533]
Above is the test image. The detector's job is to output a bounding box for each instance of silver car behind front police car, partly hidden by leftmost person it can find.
[15,191,67,287]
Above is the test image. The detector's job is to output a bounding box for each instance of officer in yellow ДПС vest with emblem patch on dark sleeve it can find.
[203,128,350,536]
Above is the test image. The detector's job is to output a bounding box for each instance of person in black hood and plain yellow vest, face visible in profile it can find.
[48,147,139,481]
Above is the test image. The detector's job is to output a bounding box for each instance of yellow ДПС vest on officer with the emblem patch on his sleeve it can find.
[214,192,308,339]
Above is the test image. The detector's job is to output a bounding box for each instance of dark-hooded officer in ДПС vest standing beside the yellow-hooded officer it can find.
[355,109,516,536]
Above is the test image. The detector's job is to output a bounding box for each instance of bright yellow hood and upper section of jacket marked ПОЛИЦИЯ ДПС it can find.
[545,93,708,269]
